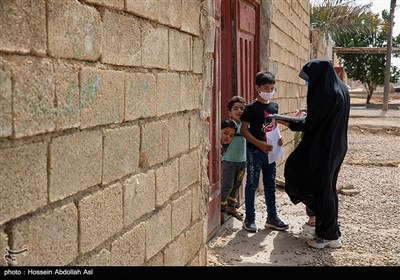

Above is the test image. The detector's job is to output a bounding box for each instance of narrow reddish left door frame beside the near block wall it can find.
[207,0,221,240]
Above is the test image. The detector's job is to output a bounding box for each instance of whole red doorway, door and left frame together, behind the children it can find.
[207,0,259,240]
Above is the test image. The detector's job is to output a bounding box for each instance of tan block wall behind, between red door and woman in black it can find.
[260,0,310,177]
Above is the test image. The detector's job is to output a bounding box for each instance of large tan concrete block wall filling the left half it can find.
[0,0,214,266]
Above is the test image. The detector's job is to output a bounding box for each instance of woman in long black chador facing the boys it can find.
[278,60,350,249]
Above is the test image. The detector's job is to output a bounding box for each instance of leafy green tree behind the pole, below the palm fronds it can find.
[335,10,400,104]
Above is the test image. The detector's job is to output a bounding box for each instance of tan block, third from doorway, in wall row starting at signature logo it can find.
[123,170,156,227]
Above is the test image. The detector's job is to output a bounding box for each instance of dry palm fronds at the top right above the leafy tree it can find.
[310,0,381,41]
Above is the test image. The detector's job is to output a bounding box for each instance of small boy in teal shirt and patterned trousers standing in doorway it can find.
[221,96,246,224]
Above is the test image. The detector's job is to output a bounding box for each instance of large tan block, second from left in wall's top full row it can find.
[47,0,103,61]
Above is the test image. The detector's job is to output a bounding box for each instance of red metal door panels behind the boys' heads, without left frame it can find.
[221,0,260,118]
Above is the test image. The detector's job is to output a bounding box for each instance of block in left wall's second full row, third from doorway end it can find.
[125,73,158,121]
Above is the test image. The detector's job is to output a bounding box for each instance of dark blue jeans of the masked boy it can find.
[245,147,277,221]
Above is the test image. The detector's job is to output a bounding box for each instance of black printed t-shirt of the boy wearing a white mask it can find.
[240,100,279,149]
